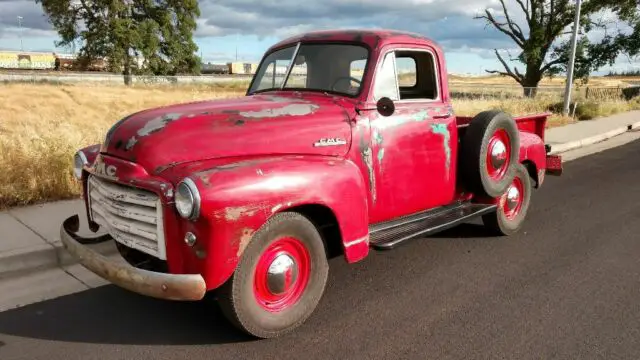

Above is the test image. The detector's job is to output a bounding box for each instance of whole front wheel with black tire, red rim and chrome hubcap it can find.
[218,213,329,338]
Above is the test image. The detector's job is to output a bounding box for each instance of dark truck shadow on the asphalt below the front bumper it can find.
[0,285,251,345]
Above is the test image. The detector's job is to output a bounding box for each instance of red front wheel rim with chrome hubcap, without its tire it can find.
[253,237,311,312]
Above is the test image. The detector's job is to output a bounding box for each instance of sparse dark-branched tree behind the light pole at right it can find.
[475,0,638,97]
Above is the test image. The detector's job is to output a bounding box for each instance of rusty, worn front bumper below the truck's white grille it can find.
[60,215,206,301]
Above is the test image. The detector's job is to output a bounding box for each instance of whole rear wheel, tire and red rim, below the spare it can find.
[482,164,533,236]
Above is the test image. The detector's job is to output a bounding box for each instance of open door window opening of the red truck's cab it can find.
[396,50,439,100]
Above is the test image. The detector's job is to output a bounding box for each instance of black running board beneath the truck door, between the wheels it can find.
[369,203,496,250]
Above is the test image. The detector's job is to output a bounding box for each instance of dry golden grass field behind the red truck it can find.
[0,80,638,208]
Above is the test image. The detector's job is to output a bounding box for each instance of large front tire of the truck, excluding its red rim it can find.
[218,212,329,338]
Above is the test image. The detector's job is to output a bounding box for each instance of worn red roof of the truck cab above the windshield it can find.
[267,29,439,52]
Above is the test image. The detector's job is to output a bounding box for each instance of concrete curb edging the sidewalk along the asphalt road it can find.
[0,118,640,279]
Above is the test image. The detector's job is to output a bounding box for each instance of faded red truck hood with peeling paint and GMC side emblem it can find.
[101,93,353,174]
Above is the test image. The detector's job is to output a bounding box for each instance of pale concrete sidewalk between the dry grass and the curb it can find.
[0,111,640,280]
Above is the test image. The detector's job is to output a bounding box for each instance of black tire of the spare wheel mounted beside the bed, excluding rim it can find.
[460,110,520,198]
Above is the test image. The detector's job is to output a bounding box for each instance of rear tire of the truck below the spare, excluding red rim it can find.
[482,164,533,236]
